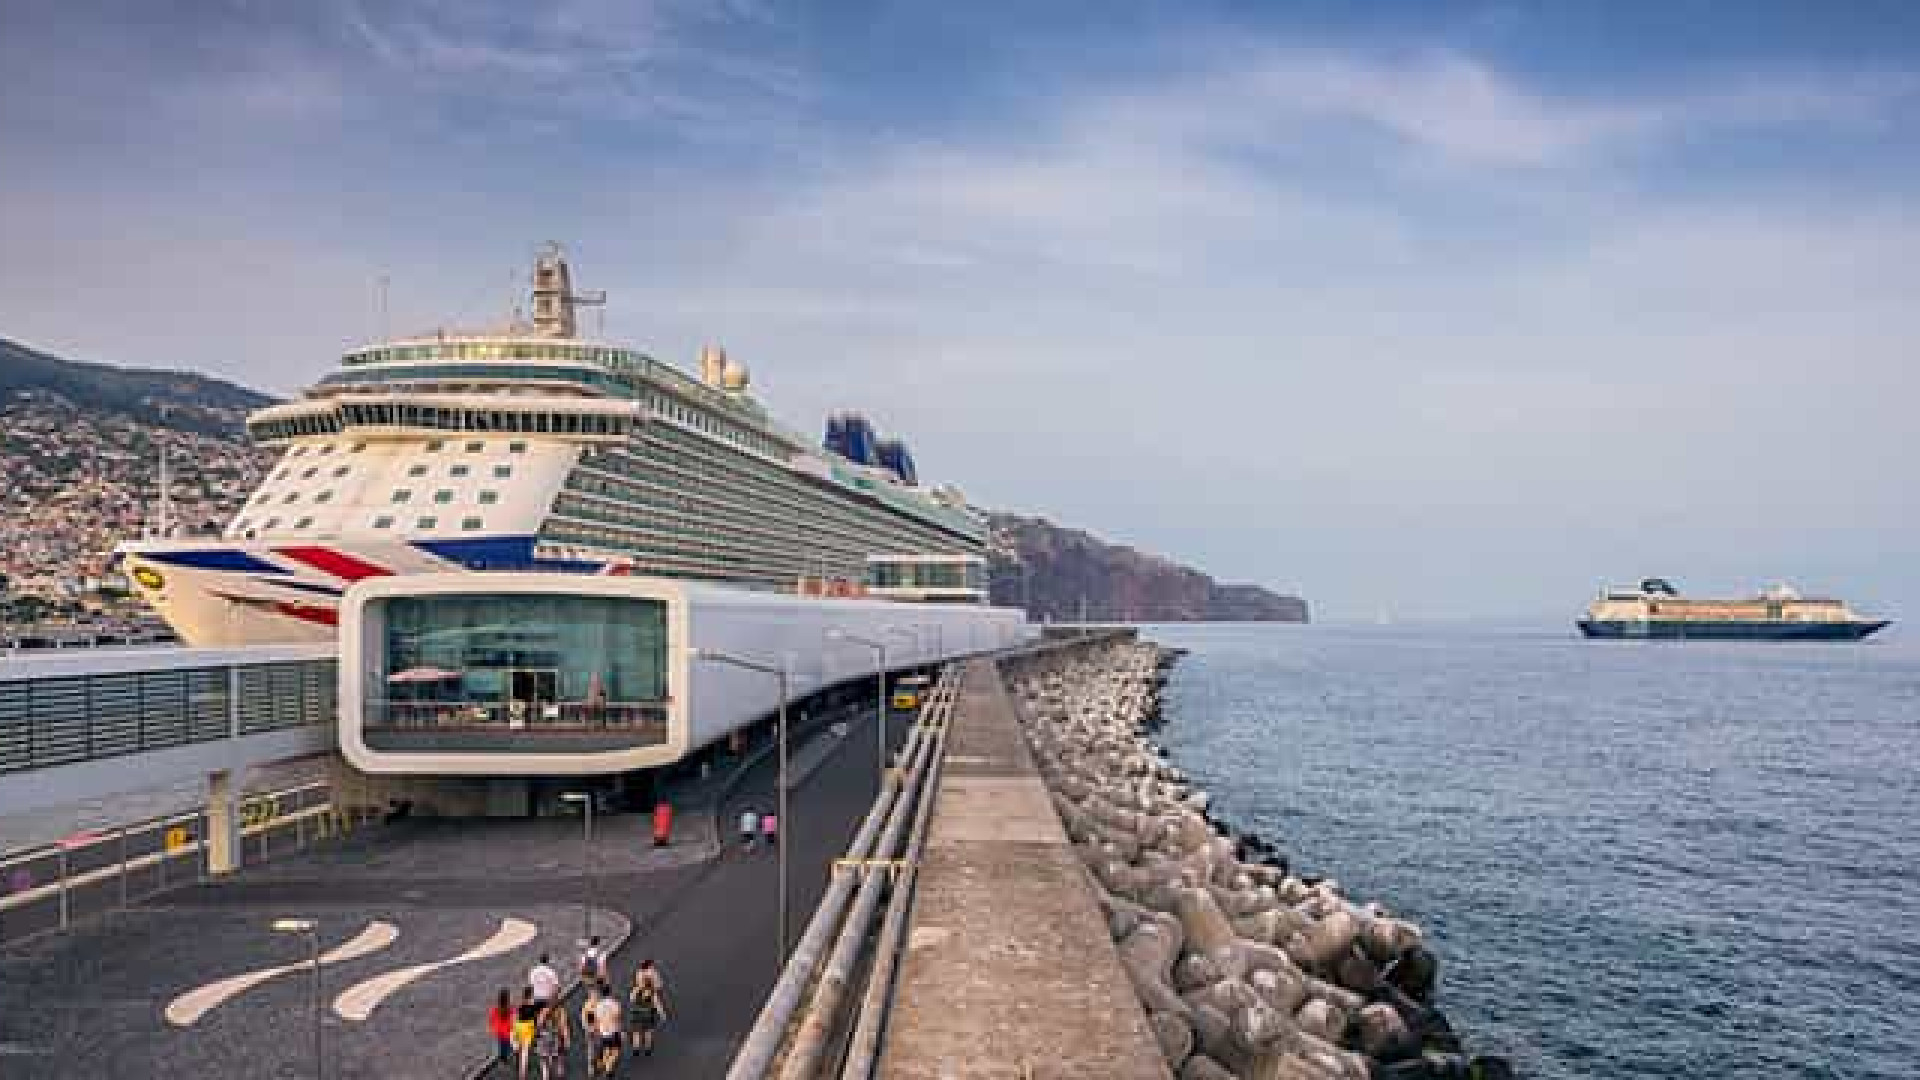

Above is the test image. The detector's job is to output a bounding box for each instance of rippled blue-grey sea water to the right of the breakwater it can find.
[1148,626,1920,1078]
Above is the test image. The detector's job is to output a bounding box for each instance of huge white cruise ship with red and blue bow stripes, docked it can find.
[121,248,985,646]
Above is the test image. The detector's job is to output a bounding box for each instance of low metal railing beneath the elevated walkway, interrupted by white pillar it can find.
[0,782,348,944]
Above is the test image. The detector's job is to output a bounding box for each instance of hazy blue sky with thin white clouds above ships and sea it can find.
[0,0,1920,623]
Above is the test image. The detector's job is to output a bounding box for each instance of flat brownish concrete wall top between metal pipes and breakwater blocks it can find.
[879,661,1169,1080]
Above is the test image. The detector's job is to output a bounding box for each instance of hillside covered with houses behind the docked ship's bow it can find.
[0,390,271,625]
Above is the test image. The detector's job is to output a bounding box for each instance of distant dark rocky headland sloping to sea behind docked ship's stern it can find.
[989,513,1308,623]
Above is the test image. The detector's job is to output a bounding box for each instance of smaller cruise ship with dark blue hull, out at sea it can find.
[1578,578,1889,642]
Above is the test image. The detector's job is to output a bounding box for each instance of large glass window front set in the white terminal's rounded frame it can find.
[372,594,666,724]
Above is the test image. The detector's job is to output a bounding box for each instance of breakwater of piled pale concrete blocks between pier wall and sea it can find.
[1004,636,1513,1080]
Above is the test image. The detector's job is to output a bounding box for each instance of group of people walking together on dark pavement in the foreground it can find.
[488,938,666,1080]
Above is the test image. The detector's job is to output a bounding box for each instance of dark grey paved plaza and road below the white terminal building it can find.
[0,691,908,1080]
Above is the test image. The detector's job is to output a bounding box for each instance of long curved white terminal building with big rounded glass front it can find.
[338,573,1031,776]
